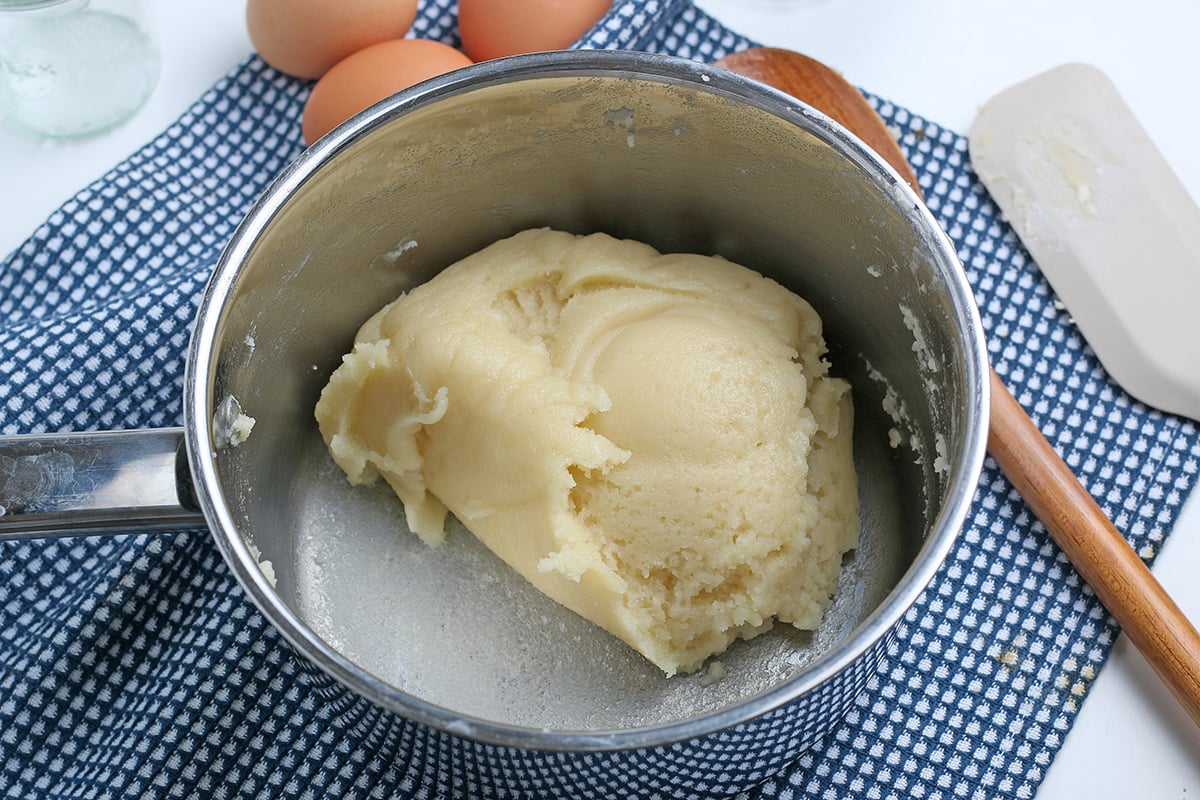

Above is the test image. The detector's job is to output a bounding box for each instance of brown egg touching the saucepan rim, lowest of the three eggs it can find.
[301,38,470,144]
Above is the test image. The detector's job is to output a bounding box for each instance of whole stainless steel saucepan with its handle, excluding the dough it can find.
[0,52,988,796]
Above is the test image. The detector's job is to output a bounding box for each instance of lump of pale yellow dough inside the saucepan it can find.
[317,229,859,674]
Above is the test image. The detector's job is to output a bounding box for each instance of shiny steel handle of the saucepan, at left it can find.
[0,428,204,541]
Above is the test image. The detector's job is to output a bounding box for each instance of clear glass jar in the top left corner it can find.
[0,0,161,138]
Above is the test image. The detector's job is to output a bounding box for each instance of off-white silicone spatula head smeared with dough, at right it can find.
[970,64,1200,419]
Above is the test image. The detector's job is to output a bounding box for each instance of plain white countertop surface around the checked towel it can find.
[0,0,1200,800]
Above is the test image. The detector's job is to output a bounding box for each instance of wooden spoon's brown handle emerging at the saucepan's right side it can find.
[988,372,1200,724]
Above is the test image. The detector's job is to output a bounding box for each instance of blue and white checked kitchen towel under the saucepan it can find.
[0,0,1200,800]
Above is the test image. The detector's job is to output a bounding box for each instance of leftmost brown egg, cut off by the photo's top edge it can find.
[246,0,418,78]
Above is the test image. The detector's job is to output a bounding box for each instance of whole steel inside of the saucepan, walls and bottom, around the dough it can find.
[210,61,974,730]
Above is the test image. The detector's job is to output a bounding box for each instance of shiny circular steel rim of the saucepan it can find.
[184,50,988,752]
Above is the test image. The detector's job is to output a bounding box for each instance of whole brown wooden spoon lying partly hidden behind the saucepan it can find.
[716,48,1200,724]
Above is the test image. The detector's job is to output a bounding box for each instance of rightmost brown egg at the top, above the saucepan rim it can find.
[458,0,612,61]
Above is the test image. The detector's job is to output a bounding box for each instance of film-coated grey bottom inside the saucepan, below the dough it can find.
[285,402,911,730]
